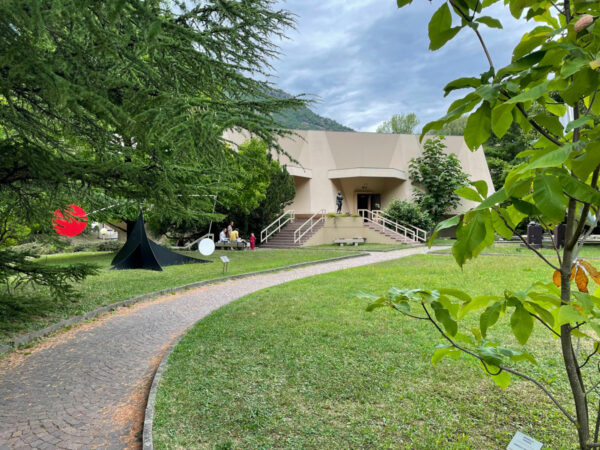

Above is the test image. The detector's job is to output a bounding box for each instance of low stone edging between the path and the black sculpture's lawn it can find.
[0,252,368,355]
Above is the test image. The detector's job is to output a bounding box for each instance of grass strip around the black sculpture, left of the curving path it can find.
[0,250,356,342]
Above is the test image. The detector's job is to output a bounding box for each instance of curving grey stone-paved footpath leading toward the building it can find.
[0,247,440,449]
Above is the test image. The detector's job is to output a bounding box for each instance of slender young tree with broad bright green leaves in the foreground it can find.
[364,0,600,449]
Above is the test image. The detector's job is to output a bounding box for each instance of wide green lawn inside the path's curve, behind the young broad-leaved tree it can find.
[154,255,580,449]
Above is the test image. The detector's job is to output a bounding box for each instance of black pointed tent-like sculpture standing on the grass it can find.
[111,211,210,270]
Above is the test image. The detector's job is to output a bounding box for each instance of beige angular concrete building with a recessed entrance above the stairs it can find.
[226,130,493,216]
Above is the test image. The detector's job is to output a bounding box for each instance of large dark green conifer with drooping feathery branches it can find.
[0,0,303,298]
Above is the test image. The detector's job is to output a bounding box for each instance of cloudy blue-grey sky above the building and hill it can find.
[273,0,533,131]
